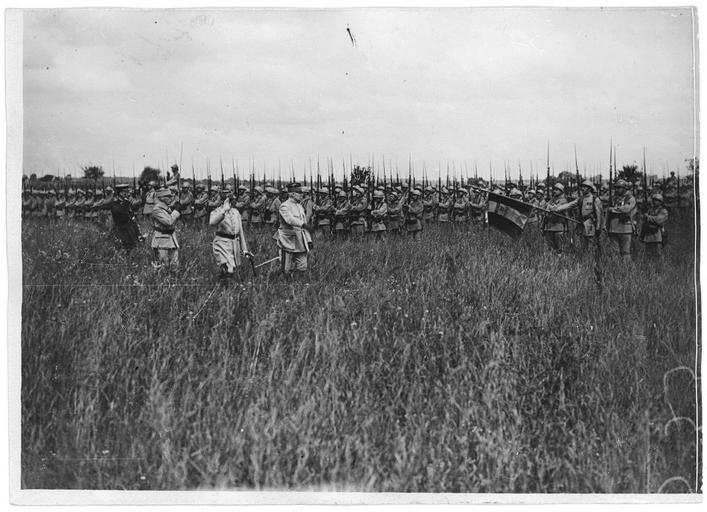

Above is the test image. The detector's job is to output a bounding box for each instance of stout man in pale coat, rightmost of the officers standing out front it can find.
[276,183,312,276]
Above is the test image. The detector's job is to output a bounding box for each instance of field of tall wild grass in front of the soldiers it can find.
[21,213,702,493]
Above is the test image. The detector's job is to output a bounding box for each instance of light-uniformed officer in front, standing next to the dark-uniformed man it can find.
[150,188,180,270]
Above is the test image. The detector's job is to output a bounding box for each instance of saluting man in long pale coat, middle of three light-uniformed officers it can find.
[209,186,253,279]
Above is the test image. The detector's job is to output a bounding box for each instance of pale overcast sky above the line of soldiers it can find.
[24,8,695,181]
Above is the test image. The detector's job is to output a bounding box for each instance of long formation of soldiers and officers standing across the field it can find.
[22,166,692,277]
